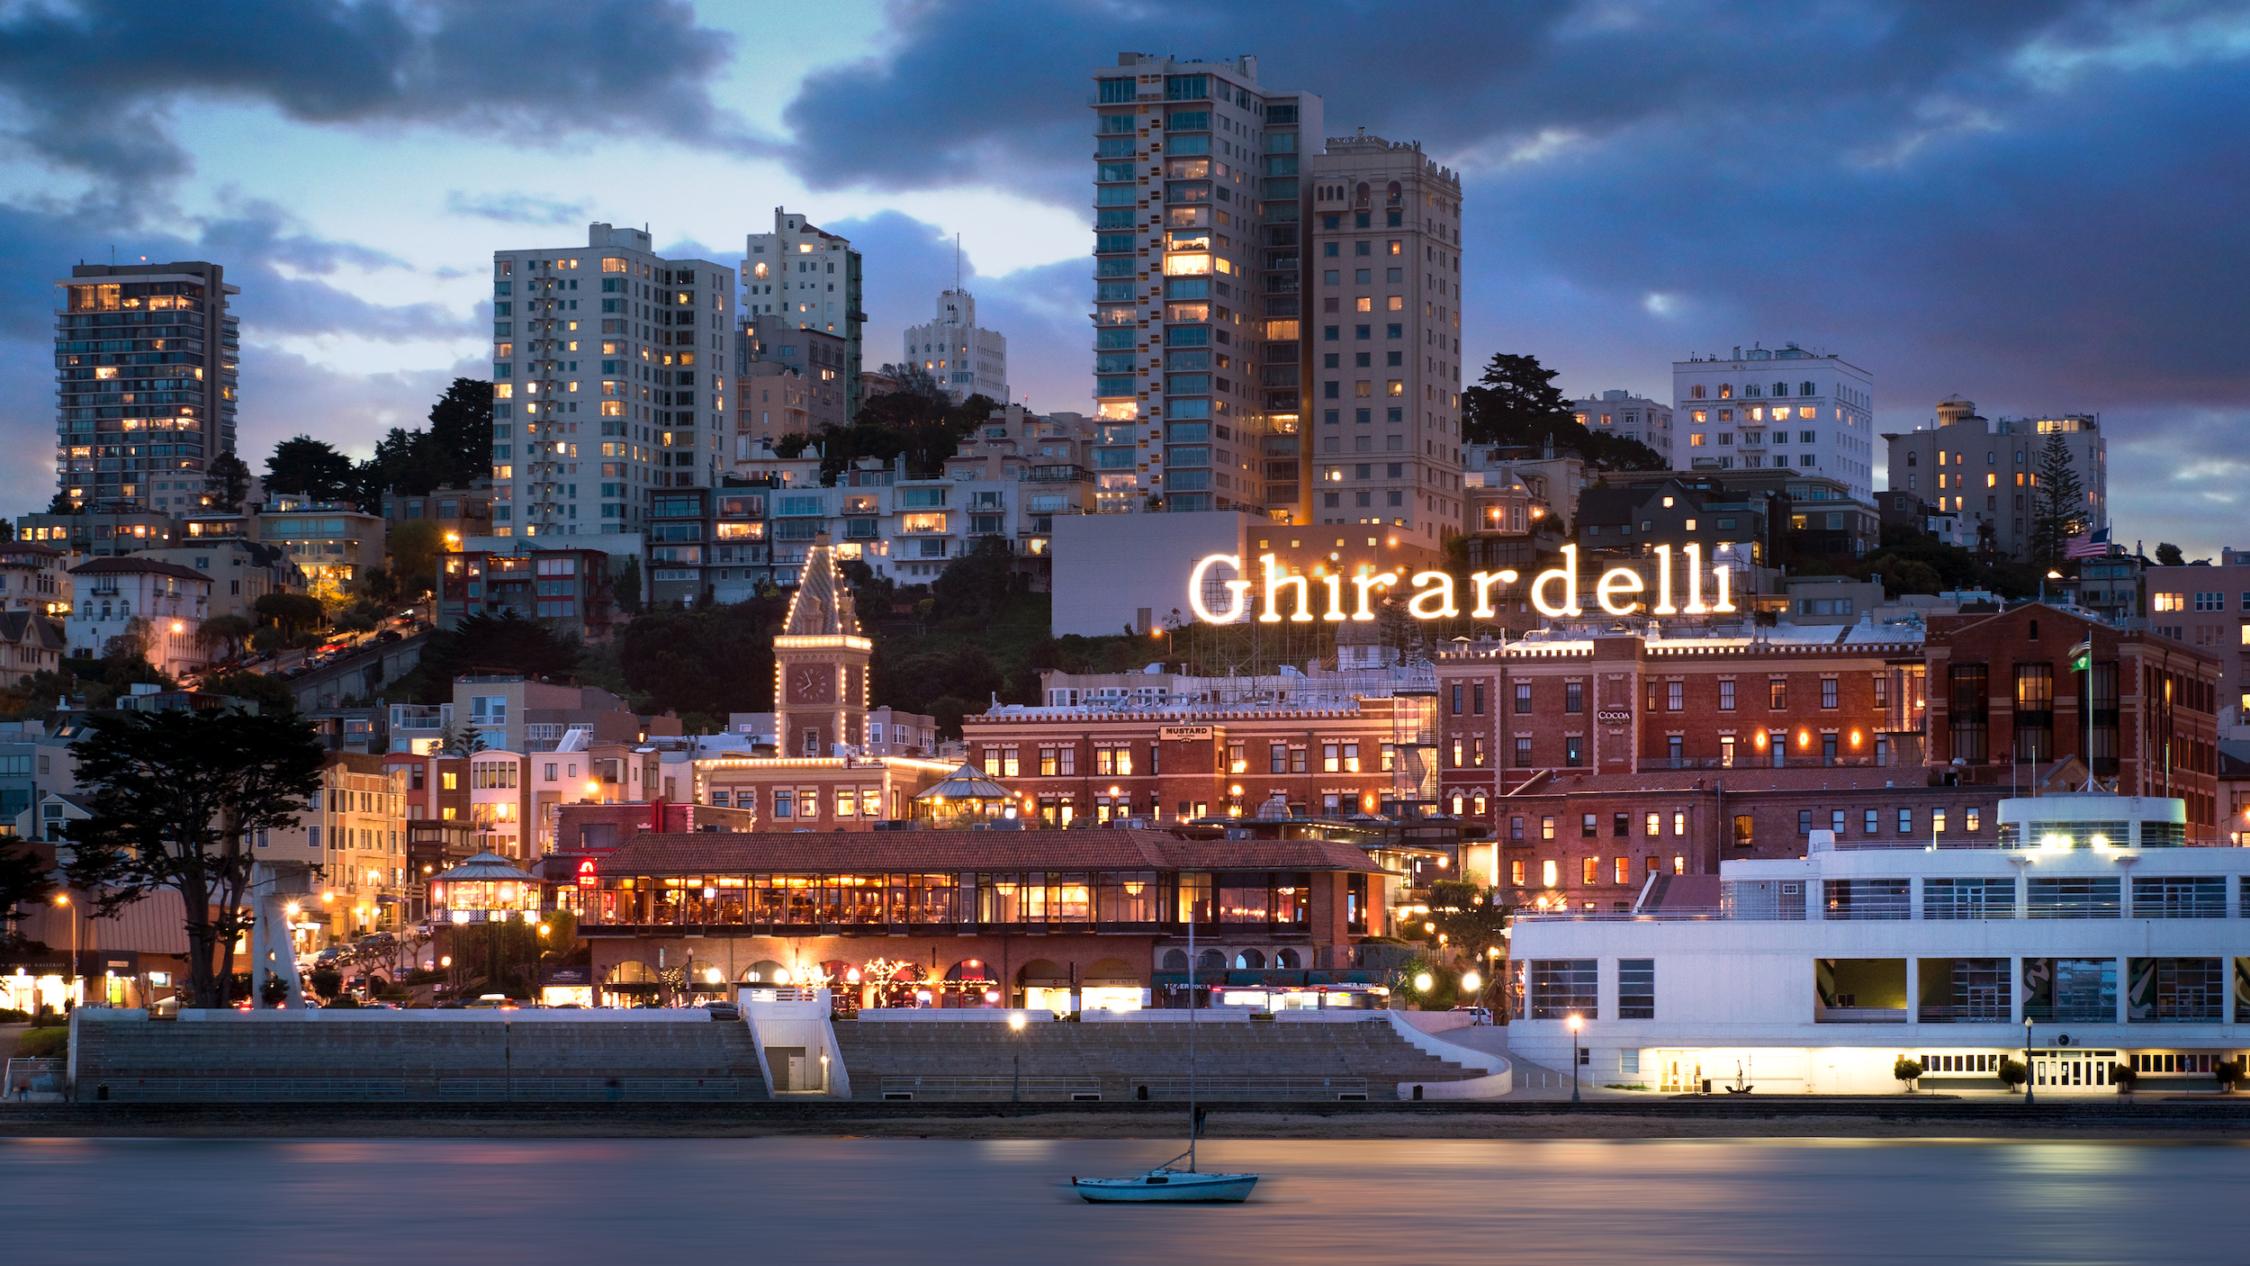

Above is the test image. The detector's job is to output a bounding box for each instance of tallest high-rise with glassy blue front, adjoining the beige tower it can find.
[1094,52,1321,522]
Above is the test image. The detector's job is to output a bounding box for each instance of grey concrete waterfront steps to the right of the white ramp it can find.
[835,1016,1481,1102]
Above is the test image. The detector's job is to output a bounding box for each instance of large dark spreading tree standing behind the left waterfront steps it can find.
[65,708,326,1007]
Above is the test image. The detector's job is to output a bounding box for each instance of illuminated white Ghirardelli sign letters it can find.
[1188,544,1735,625]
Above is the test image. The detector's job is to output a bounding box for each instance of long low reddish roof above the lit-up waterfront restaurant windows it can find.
[601,830,1382,875]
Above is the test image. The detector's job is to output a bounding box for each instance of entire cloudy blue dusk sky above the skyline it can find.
[0,0,2250,558]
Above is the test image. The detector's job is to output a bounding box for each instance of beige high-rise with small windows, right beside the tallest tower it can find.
[1303,128,1465,539]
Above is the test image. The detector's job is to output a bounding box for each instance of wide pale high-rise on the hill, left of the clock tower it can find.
[493,223,736,537]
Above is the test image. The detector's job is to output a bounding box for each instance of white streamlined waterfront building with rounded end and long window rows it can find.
[1508,792,2250,1095]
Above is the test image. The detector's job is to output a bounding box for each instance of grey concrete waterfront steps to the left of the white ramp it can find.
[72,1012,770,1102]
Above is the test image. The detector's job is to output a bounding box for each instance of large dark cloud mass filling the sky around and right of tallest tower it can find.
[785,0,2250,553]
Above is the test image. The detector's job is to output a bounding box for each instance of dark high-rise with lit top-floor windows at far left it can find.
[54,261,241,513]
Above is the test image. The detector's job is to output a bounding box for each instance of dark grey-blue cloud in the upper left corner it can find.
[0,0,752,189]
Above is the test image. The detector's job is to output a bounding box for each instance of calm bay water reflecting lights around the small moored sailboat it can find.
[0,1138,2250,1266]
